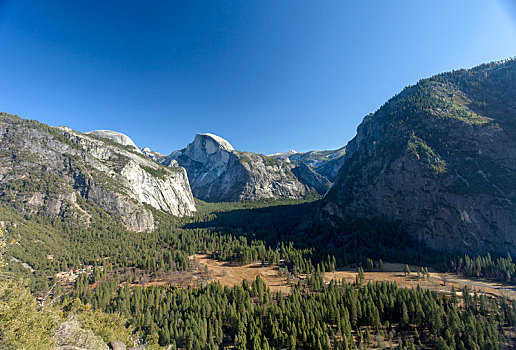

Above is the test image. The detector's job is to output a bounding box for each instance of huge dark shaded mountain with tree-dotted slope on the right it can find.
[321,60,516,254]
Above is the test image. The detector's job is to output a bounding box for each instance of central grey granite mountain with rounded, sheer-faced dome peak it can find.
[164,134,321,202]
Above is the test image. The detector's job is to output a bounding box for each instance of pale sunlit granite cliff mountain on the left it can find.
[0,113,195,231]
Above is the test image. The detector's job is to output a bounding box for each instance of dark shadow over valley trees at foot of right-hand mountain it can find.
[183,201,449,266]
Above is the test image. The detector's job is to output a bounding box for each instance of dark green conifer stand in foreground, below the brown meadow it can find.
[79,273,508,349]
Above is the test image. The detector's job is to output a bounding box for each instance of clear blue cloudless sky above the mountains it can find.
[0,0,516,154]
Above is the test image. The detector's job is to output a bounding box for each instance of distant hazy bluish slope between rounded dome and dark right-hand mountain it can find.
[269,147,346,182]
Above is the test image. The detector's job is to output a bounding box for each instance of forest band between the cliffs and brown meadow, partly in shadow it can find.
[0,199,440,294]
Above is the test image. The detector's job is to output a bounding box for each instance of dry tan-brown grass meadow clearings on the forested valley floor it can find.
[117,254,516,300]
